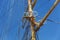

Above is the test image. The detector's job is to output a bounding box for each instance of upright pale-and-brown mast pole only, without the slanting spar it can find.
[28,0,36,40]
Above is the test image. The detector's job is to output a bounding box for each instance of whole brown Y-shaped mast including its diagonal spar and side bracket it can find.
[24,0,60,40]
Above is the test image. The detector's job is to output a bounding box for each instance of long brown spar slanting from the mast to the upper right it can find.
[35,0,60,31]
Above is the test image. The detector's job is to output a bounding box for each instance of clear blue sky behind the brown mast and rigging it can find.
[0,0,60,40]
